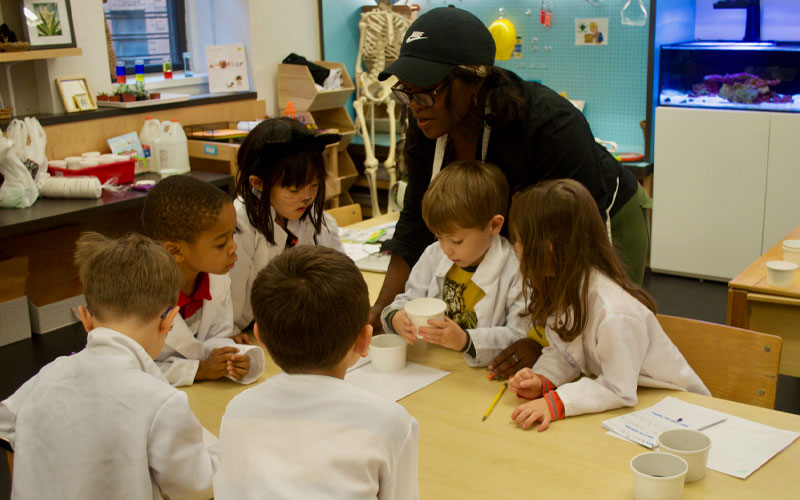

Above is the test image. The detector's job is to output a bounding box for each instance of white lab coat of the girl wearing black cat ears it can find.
[229,199,344,330]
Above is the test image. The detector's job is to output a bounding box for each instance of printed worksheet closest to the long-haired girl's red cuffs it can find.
[603,396,726,448]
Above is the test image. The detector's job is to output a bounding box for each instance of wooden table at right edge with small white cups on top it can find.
[727,226,800,377]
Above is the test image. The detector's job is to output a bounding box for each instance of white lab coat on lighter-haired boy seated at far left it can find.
[0,328,219,500]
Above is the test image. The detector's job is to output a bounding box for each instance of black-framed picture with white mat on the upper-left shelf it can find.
[20,0,75,50]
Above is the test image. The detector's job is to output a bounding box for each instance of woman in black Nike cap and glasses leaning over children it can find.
[370,7,650,378]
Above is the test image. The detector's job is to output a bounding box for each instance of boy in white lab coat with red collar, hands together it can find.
[142,175,265,386]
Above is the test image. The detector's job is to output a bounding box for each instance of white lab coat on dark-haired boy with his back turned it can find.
[214,373,419,500]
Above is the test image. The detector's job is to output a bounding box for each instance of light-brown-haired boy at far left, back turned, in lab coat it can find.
[0,233,219,500]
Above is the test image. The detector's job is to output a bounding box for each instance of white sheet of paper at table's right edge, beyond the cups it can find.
[703,415,800,479]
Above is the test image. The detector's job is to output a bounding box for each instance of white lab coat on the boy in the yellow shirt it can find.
[381,235,531,366]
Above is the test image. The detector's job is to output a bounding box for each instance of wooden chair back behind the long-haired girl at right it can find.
[656,314,783,408]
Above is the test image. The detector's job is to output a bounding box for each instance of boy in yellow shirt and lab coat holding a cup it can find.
[381,161,544,366]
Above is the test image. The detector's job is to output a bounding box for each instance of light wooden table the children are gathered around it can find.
[183,214,800,499]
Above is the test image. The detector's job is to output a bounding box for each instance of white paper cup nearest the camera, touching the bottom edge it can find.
[631,451,689,500]
